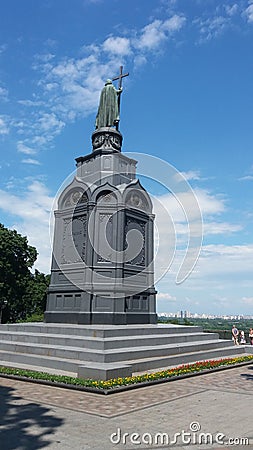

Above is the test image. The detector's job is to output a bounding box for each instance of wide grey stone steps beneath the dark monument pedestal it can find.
[0,323,252,380]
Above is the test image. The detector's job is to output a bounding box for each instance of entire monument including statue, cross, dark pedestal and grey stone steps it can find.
[0,67,245,380]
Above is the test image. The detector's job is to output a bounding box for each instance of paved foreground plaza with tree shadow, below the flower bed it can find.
[0,365,253,450]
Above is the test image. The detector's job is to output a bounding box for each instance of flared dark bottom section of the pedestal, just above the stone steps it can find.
[44,287,157,325]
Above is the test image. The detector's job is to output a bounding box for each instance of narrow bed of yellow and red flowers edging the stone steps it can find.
[0,355,253,394]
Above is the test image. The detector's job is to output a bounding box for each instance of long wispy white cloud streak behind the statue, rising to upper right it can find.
[8,13,186,155]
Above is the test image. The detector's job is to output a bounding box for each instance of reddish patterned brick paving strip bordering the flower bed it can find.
[0,378,203,417]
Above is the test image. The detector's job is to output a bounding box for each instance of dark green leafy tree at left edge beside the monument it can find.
[0,224,49,322]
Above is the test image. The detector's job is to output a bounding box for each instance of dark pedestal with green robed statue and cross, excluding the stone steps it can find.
[45,66,156,325]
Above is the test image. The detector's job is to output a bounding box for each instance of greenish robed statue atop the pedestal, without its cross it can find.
[96,79,122,129]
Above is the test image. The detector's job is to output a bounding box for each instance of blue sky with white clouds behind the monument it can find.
[0,0,253,314]
